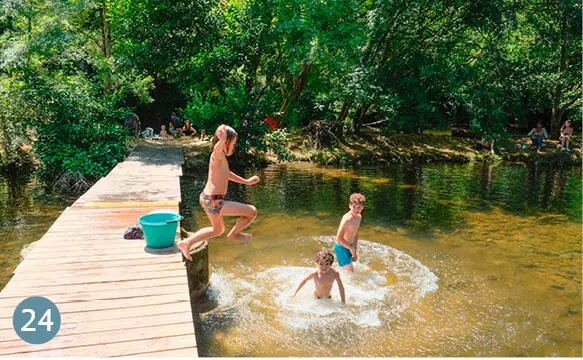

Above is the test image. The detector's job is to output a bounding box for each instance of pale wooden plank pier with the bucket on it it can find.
[0,143,198,357]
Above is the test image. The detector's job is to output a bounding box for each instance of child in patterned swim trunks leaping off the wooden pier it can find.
[177,125,259,261]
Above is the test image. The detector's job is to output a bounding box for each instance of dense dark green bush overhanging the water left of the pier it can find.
[26,71,128,193]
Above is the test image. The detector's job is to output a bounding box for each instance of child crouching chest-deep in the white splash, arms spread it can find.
[292,249,346,304]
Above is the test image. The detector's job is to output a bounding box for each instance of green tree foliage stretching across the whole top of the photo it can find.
[0,0,582,177]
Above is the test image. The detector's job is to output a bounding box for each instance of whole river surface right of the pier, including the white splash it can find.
[183,163,582,356]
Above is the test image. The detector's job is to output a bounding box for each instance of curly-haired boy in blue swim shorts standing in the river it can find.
[334,193,365,271]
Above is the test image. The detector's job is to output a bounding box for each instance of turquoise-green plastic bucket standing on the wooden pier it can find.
[138,212,182,248]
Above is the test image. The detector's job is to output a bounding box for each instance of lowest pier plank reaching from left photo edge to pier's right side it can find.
[0,332,196,357]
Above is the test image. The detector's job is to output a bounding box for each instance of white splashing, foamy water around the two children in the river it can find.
[196,236,438,354]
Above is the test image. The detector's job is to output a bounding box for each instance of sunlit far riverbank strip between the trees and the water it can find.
[180,131,582,170]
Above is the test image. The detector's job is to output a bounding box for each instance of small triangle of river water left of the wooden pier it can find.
[0,176,74,289]
